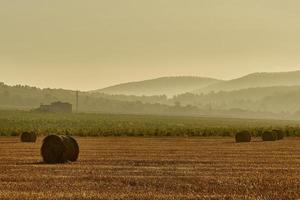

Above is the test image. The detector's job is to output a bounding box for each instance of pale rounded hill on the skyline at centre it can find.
[93,76,223,96]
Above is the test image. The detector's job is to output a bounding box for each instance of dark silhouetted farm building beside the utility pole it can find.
[35,101,72,113]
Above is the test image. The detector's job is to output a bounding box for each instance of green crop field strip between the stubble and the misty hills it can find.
[0,111,300,136]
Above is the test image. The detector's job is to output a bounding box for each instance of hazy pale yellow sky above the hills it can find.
[0,0,300,90]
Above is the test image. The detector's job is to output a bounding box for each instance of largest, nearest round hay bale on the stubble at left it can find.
[41,135,79,163]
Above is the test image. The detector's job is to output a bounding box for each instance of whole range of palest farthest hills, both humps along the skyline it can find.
[92,71,300,97]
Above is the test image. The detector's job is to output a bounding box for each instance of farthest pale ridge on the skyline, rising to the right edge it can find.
[194,71,300,93]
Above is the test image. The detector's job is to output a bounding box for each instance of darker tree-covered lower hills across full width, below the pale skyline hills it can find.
[0,83,300,118]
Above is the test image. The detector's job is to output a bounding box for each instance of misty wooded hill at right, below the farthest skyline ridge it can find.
[172,86,300,113]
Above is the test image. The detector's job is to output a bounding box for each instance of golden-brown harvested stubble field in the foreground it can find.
[0,137,300,200]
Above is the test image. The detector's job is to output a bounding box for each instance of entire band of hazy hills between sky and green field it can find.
[0,71,300,119]
